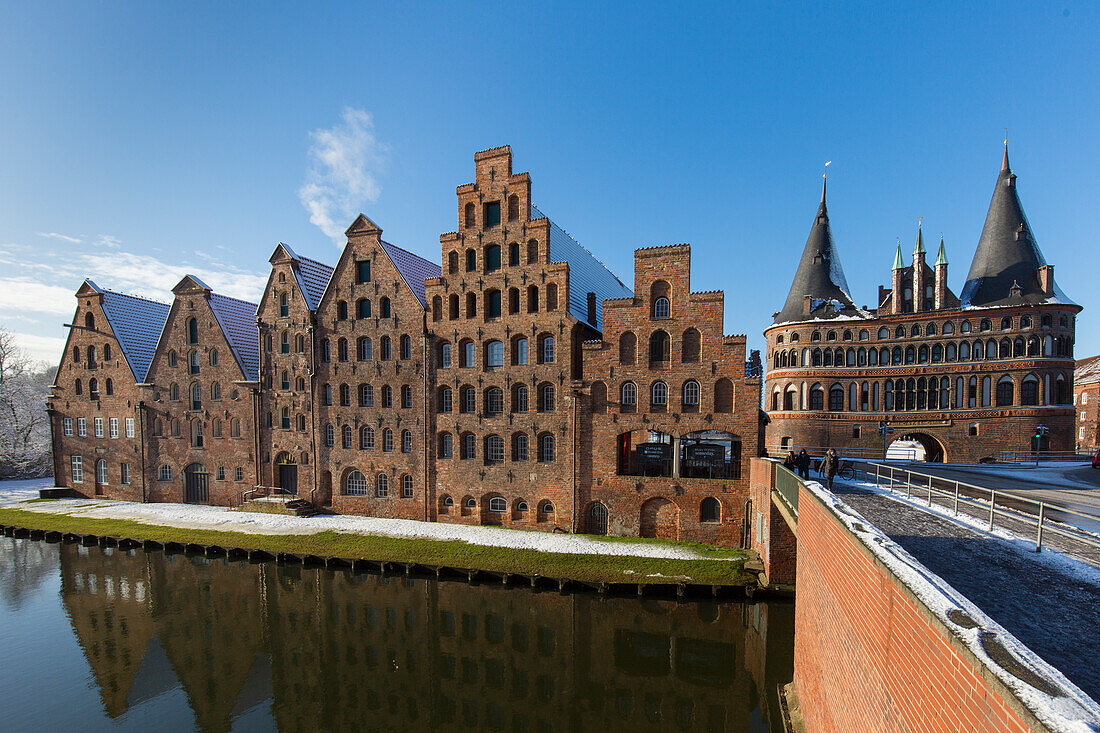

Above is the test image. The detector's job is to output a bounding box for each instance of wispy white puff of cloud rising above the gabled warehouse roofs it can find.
[298,108,389,242]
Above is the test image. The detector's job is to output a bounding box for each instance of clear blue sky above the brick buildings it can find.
[0,0,1100,362]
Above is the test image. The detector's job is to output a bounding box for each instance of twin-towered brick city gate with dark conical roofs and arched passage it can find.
[765,144,1081,461]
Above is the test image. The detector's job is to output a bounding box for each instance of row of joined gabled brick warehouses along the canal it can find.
[48,146,760,544]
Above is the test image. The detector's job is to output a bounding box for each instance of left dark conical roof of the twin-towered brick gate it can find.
[774,176,862,324]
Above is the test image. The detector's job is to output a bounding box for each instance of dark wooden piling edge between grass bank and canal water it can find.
[0,524,774,600]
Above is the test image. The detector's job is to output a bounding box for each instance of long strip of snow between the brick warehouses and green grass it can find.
[0,479,739,561]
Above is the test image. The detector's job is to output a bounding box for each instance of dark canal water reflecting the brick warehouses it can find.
[0,537,794,732]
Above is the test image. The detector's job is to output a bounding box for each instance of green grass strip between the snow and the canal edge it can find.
[0,507,756,586]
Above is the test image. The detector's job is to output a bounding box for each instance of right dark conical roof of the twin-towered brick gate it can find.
[961,140,1049,306]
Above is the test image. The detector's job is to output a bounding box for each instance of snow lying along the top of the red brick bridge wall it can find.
[804,481,1100,733]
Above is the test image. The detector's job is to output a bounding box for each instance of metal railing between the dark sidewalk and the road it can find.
[858,462,1100,553]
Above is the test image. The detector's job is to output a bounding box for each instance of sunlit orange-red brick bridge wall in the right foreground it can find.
[794,479,1032,733]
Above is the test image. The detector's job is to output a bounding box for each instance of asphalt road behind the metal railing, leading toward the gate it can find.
[866,462,1100,533]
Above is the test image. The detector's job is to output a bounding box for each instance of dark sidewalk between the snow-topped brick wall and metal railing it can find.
[834,481,1100,700]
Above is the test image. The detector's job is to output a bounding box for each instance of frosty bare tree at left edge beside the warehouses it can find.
[0,328,55,479]
